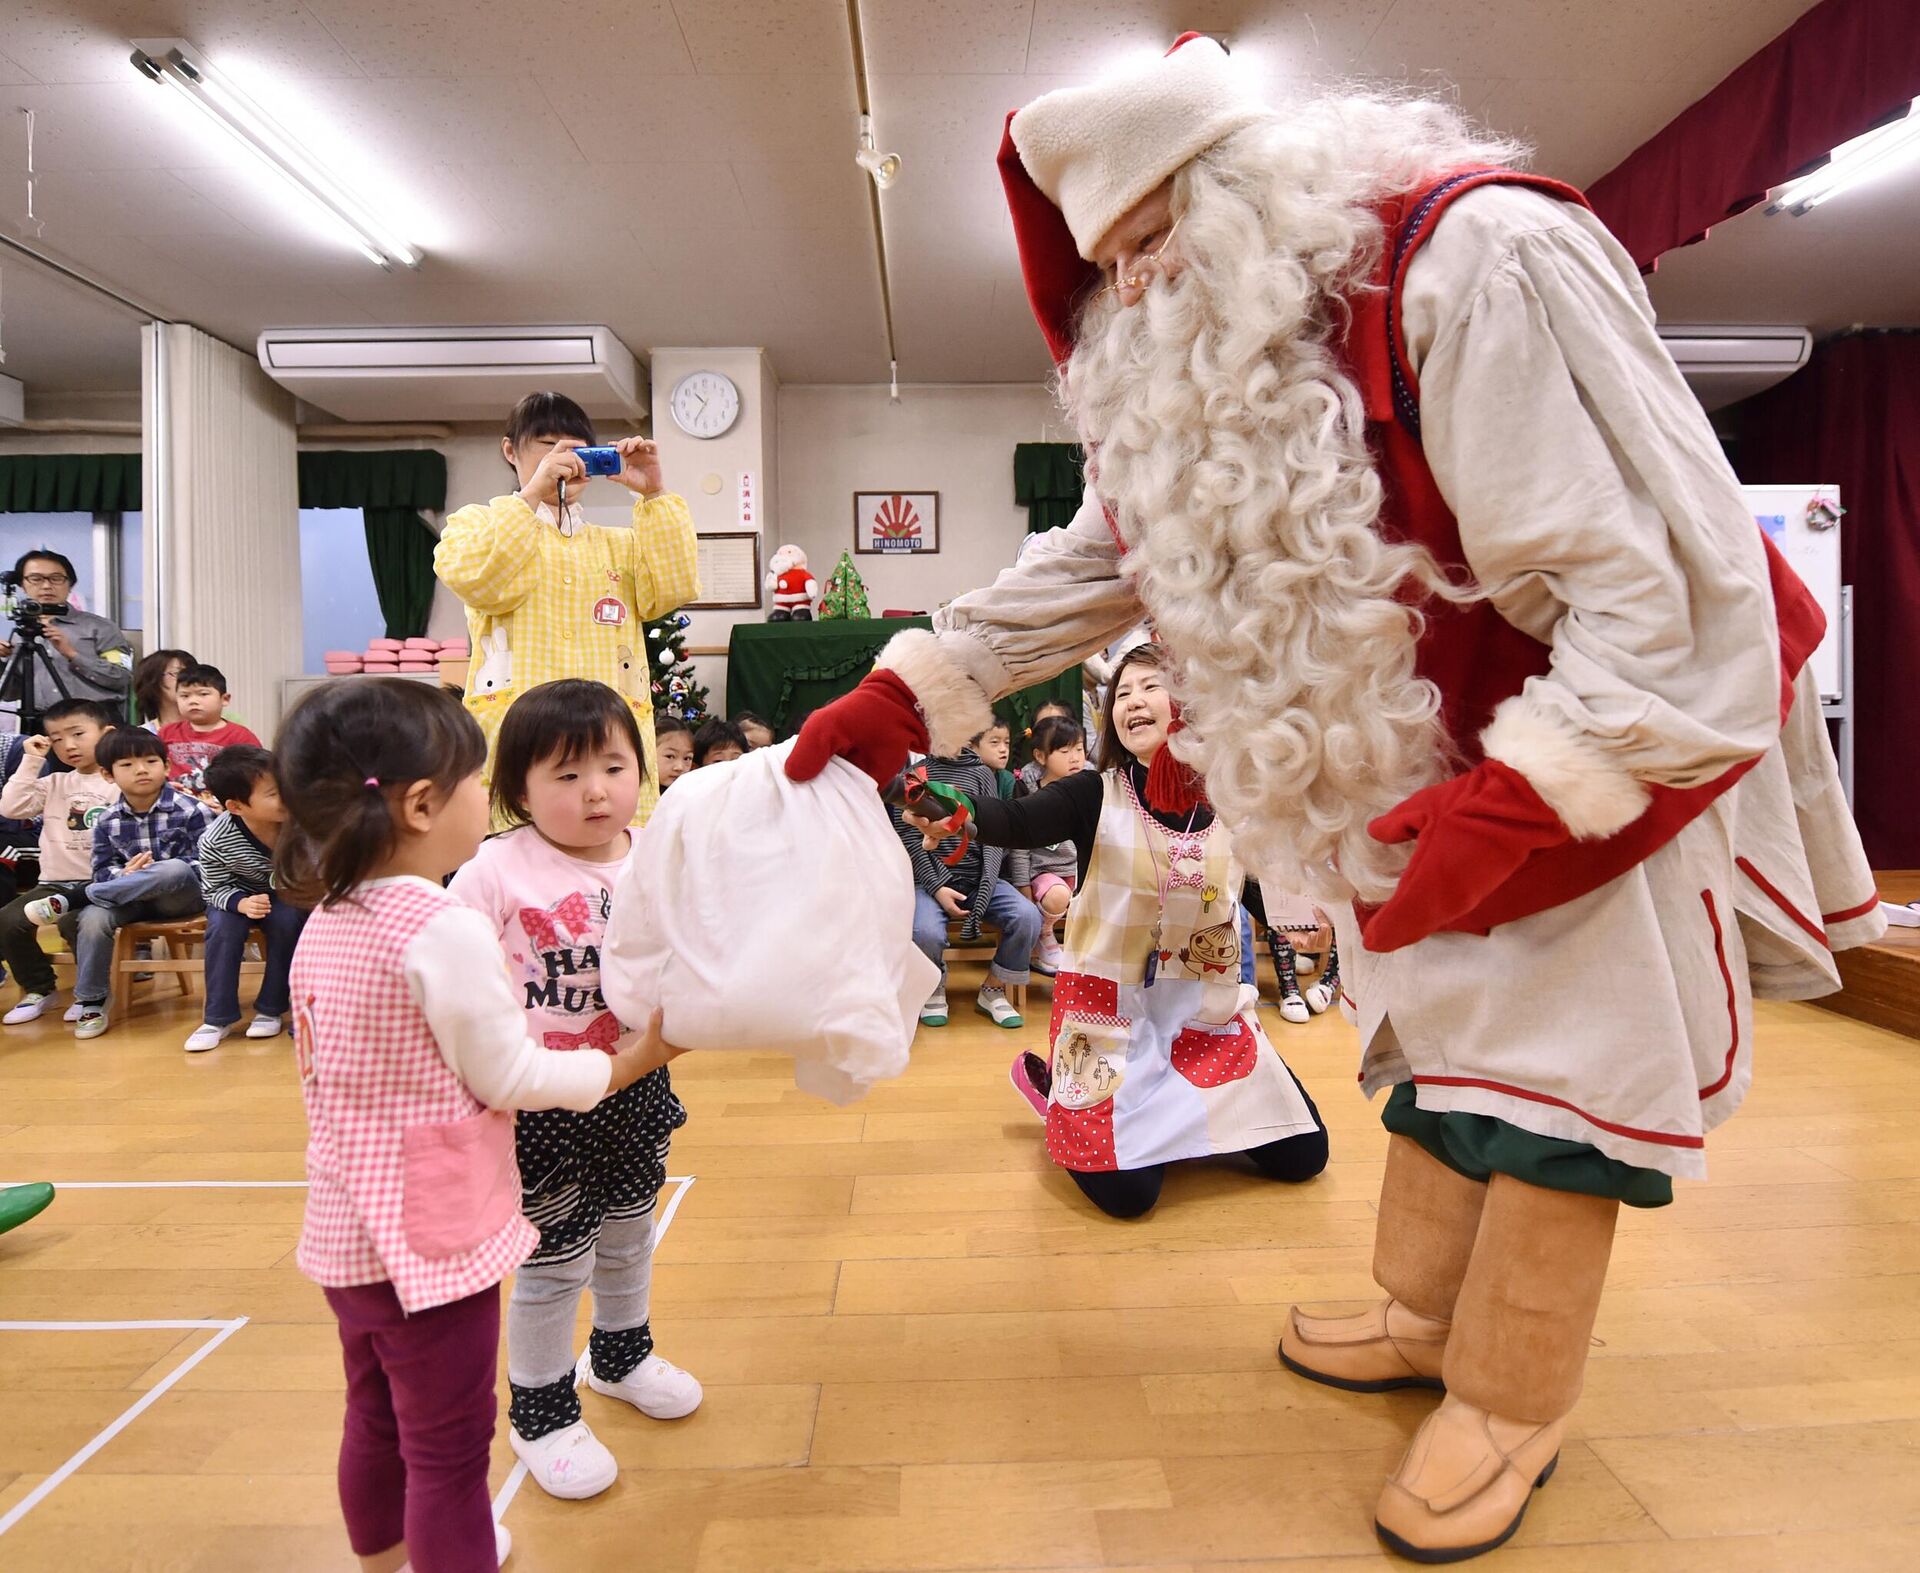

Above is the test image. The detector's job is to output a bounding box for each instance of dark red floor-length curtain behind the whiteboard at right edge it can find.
[1736,328,1920,868]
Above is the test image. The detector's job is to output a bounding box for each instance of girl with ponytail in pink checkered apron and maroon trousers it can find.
[278,678,672,1573]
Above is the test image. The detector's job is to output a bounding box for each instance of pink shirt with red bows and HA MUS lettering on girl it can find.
[449,826,641,1054]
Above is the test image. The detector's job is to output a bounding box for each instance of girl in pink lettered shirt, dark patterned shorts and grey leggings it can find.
[453,678,701,1498]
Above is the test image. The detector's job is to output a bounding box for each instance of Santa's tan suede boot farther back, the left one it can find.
[1281,1135,1486,1392]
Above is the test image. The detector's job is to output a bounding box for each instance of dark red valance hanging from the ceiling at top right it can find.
[1586,0,1920,271]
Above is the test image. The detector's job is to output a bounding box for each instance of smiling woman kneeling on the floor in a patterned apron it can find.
[916,645,1327,1218]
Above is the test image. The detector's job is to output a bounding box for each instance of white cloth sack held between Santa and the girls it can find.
[601,743,939,1102]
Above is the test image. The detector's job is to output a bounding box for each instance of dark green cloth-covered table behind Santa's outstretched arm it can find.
[726,617,1081,745]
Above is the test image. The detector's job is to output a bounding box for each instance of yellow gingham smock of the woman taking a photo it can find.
[434,451,701,824]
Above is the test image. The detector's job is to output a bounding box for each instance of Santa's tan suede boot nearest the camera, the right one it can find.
[1375,1174,1620,1561]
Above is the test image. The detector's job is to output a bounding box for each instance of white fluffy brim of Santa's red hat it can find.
[1010,33,1267,259]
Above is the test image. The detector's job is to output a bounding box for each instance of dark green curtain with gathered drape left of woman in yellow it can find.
[300,448,447,640]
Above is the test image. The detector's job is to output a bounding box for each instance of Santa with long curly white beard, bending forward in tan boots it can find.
[789,36,1882,1561]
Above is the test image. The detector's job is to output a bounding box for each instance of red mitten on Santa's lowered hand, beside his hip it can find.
[1359,759,1572,953]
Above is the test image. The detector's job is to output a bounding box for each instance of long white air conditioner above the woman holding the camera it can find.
[259,327,649,421]
